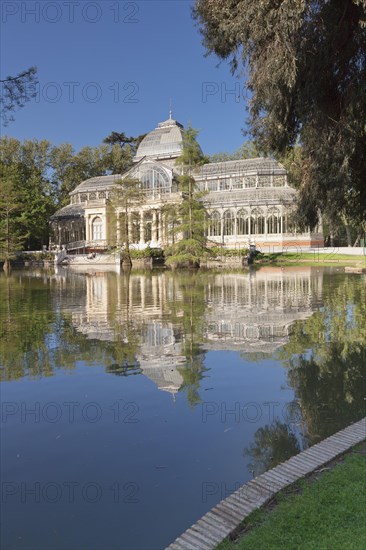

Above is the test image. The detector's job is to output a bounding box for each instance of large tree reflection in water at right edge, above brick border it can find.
[277,275,366,444]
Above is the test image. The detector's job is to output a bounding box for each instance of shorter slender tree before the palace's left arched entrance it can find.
[109,176,145,267]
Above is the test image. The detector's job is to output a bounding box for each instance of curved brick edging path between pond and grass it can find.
[167,417,366,550]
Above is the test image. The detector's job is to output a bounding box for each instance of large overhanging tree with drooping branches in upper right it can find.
[193,0,366,227]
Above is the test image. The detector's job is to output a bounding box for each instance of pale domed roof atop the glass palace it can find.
[134,113,184,162]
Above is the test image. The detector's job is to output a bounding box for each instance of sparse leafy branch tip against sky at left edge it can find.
[0,67,38,126]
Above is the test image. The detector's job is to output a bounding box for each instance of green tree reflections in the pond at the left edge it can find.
[0,275,140,380]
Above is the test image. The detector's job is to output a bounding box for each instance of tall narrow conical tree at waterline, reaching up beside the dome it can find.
[166,127,207,267]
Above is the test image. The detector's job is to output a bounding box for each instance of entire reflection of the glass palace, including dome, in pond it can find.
[53,267,323,393]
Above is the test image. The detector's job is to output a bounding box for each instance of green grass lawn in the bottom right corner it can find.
[217,443,366,550]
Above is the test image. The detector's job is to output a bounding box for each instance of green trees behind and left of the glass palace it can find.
[0,134,146,254]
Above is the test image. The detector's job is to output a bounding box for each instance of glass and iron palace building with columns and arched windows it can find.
[51,117,323,252]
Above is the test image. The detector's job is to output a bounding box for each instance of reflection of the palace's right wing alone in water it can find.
[204,268,322,353]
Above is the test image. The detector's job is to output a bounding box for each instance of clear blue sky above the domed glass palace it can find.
[1,0,250,154]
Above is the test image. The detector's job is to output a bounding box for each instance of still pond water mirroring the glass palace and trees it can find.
[0,267,366,550]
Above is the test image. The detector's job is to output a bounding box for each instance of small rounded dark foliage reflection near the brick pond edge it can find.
[244,419,300,476]
